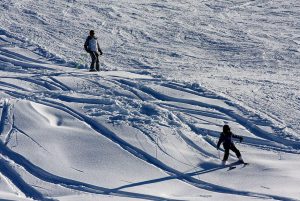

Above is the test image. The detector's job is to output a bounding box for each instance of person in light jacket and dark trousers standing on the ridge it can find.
[84,30,102,71]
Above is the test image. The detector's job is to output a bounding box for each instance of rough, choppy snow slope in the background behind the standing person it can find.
[0,0,300,137]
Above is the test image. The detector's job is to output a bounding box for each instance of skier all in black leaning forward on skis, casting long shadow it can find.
[217,125,244,165]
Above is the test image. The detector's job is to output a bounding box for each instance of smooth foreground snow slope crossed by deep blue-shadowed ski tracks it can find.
[0,33,300,200]
